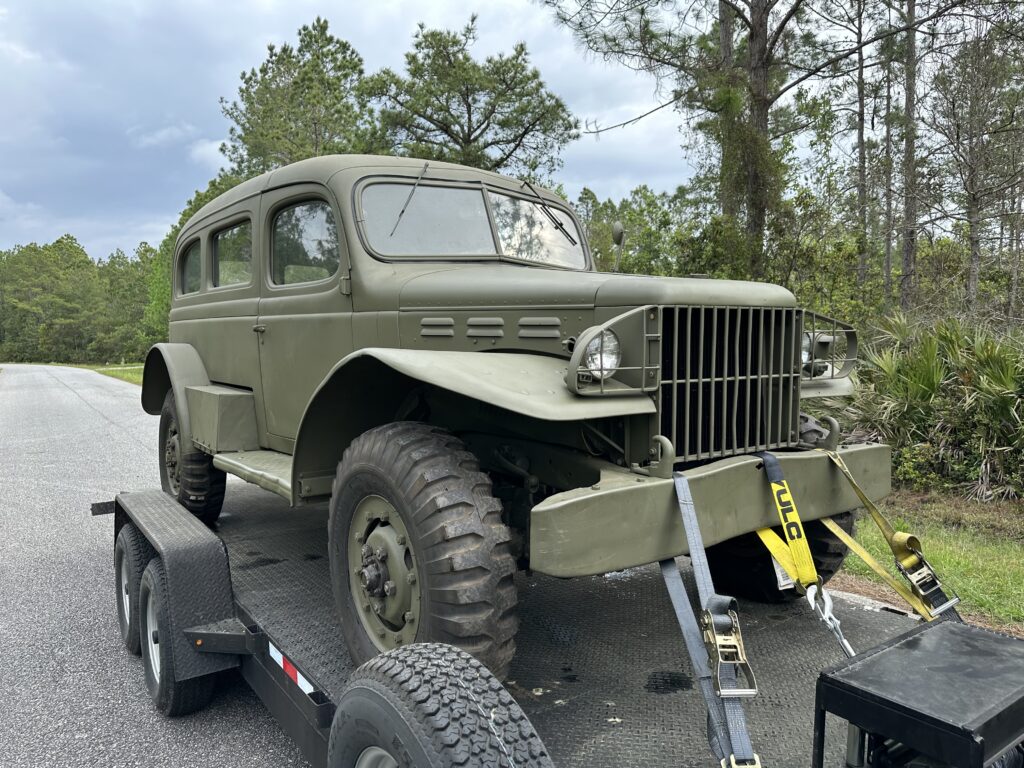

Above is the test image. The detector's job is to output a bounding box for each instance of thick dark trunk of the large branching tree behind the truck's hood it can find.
[746,0,771,280]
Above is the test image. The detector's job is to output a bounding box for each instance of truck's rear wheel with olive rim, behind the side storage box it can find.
[158,389,227,525]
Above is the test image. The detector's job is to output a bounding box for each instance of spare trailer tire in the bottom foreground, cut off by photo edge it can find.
[328,643,554,768]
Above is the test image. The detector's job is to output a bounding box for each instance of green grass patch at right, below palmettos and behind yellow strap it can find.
[838,490,1024,634]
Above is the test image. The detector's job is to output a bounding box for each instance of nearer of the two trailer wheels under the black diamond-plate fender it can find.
[138,557,214,717]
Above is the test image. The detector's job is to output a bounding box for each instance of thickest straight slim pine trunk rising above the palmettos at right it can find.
[899,0,918,309]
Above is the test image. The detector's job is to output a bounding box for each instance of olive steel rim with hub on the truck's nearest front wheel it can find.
[348,495,421,650]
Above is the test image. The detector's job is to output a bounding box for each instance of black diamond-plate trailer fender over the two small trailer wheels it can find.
[114,490,240,680]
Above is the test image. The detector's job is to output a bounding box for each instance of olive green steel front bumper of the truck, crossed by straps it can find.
[529,445,891,577]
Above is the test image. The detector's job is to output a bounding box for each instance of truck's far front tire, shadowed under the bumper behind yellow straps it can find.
[708,512,854,603]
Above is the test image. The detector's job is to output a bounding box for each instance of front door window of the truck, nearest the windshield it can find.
[270,200,339,286]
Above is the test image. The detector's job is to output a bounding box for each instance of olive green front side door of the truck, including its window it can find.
[255,184,352,454]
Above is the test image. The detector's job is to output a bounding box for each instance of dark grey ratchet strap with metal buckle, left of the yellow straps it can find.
[659,474,761,768]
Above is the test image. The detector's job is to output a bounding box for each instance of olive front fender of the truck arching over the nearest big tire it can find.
[292,347,655,504]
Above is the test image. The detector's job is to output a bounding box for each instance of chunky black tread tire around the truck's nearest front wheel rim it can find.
[328,422,518,678]
